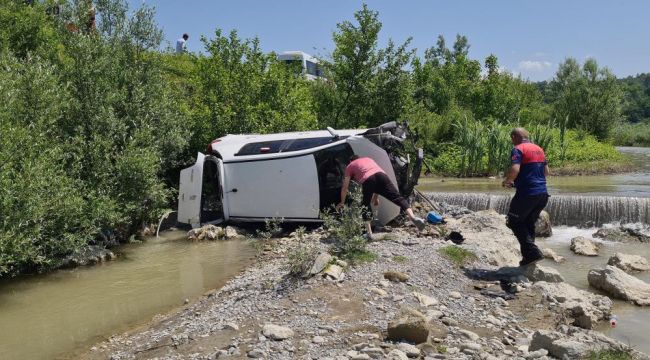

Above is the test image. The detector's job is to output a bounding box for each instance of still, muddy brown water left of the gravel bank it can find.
[0,231,254,359]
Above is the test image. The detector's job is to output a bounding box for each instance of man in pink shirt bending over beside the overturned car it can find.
[336,155,425,237]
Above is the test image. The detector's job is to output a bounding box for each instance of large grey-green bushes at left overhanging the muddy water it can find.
[0,0,186,276]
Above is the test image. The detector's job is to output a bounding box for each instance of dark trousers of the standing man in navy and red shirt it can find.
[507,192,548,262]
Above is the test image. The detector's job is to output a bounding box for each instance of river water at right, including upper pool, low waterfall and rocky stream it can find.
[418,148,650,354]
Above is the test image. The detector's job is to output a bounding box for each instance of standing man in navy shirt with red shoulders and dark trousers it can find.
[503,128,549,266]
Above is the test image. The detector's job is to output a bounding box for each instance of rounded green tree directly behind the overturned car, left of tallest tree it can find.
[189,30,316,151]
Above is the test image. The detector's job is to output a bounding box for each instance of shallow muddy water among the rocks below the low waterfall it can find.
[536,227,650,354]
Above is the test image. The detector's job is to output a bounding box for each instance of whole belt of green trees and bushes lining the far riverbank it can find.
[0,0,644,277]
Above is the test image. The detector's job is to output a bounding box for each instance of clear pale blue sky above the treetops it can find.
[129,0,650,81]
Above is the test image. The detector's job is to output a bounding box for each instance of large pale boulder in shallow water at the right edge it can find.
[587,265,650,306]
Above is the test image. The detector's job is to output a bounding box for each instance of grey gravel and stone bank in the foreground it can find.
[82,211,648,360]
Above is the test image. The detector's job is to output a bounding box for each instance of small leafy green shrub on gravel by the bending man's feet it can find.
[322,187,367,257]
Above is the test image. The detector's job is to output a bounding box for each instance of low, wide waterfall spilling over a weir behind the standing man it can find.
[428,193,650,226]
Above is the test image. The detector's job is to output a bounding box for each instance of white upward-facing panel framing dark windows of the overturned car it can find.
[209,129,366,161]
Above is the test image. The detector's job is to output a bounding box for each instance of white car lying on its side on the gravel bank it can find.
[178,122,423,227]
